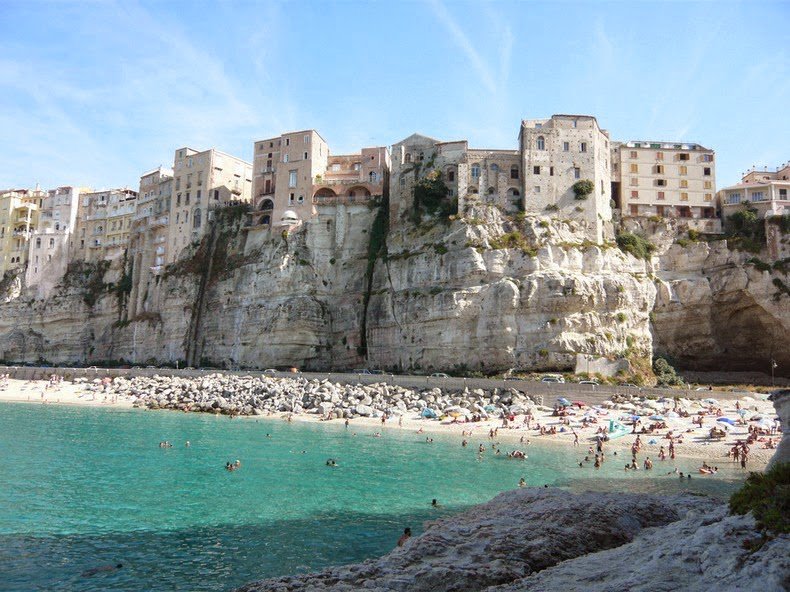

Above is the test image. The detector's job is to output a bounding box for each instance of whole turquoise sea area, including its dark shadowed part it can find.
[0,404,743,591]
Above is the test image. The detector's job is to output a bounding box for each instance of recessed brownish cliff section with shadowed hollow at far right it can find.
[653,241,790,374]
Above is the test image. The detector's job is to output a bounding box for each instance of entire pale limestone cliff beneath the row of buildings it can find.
[0,205,790,380]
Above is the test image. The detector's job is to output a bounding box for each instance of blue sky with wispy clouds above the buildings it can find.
[0,0,790,188]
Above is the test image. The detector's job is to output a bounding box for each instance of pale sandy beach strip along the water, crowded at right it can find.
[0,379,781,470]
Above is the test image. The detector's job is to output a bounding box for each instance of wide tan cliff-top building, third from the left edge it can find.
[70,189,137,262]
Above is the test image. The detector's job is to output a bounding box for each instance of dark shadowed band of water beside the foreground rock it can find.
[0,500,458,592]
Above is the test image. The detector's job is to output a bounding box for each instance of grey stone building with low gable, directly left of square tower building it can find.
[390,134,523,225]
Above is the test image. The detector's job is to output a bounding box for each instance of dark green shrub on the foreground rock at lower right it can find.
[730,463,790,533]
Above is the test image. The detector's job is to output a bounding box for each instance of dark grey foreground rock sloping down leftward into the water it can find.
[235,488,713,592]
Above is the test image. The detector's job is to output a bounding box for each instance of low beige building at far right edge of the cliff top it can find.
[718,162,790,220]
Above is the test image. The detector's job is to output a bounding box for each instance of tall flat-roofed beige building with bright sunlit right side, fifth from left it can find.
[165,147,252,263]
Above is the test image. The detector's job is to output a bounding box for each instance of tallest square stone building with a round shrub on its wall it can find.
[519,115,612,242]
